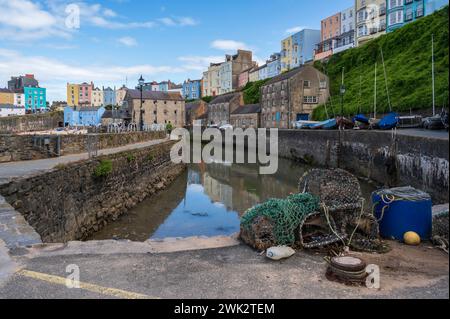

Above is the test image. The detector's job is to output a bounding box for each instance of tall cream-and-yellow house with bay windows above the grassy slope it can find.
[355,0,386,46]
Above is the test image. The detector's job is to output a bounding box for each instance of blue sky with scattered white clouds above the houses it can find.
[0,0,354,101]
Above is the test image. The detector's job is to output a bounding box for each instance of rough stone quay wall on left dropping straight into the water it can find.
[0,142,185,243]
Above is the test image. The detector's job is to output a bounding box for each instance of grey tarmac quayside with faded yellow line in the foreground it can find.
[0,243,449,299]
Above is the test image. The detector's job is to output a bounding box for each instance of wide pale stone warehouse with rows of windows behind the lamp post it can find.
[125,90,185,127]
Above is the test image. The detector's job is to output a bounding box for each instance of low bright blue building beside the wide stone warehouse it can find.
[64,106,106,127]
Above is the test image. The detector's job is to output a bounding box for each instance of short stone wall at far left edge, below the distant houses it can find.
[0,112,64,134]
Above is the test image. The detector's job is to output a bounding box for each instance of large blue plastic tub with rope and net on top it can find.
[372,187,433,240]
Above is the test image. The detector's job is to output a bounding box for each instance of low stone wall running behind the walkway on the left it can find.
[0,132,166,163]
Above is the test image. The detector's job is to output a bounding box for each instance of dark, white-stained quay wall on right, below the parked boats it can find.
[279,130,449,203]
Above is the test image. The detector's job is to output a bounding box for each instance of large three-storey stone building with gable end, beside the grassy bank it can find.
[261,65,329,128]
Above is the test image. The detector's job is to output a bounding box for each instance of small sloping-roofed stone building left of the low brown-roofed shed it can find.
[208,92,244,125]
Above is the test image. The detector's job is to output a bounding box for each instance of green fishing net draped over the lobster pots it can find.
[241,193,319,245]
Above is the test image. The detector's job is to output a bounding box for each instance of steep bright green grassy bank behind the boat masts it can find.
[313,6,449,120]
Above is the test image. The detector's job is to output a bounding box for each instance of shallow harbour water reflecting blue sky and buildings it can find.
[91,159,374,241]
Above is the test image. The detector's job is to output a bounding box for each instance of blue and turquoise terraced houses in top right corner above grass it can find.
[386,0,448,32]
